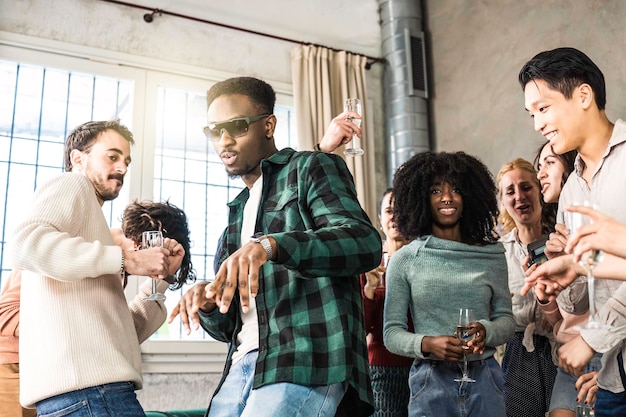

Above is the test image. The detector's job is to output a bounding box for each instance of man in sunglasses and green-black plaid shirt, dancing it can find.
[176,77,381,417]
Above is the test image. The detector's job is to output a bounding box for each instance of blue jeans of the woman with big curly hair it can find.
[409,358,506,417]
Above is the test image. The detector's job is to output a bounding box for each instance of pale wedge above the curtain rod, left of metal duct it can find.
[129,0,381,57]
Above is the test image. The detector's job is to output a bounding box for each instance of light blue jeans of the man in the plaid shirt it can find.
[209,350,346,417]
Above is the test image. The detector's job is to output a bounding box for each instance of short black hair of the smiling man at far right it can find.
[518,47,606,110]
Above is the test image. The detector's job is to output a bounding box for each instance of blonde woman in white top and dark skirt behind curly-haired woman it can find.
[496,158,556,417]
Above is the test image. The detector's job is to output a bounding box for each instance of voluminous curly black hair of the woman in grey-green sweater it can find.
[393,151,499,245]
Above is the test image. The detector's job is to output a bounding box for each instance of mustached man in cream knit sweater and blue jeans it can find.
[12,121,184,417]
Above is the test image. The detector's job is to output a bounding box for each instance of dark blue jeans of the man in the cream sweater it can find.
[37,382,146,417]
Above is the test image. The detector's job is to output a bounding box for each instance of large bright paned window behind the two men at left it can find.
[0,44,297,372]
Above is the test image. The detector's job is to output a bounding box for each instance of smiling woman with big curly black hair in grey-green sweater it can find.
[384,152,515,417]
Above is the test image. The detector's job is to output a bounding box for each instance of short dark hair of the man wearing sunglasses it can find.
[207,77,276,114]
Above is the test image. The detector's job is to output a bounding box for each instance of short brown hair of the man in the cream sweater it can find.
[65,119,135,172]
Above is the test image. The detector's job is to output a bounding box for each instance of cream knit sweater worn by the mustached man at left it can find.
[11,173,167,407]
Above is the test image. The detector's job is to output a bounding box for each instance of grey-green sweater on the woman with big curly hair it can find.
[384,236,515,360]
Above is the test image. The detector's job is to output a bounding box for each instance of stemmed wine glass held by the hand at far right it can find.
[564,202,610,330]
